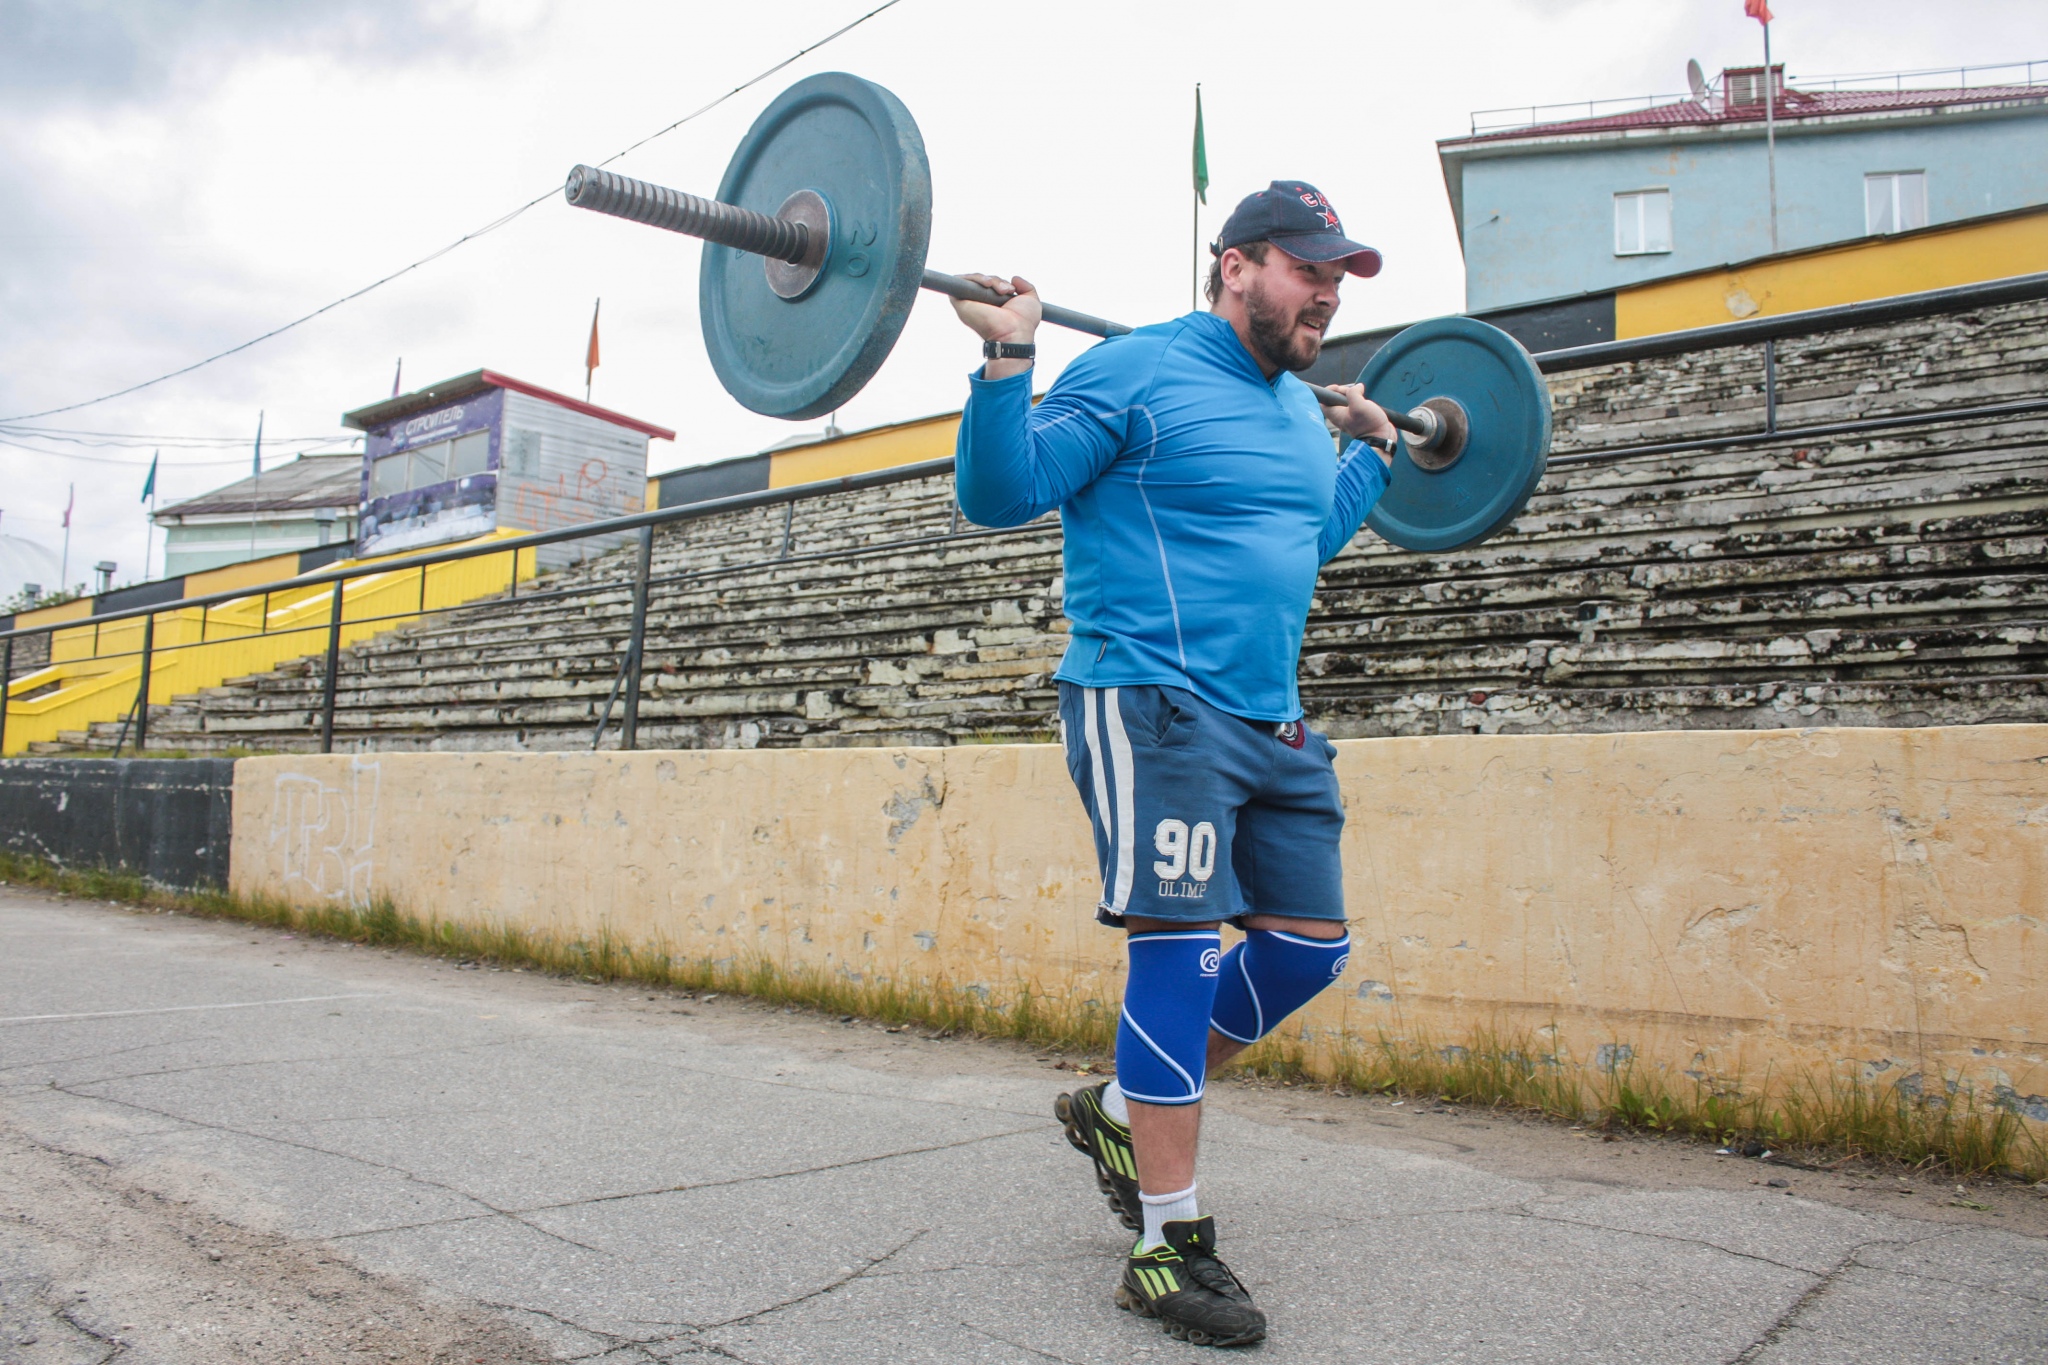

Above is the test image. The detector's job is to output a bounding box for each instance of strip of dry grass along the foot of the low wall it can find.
[0,851,2048,1181]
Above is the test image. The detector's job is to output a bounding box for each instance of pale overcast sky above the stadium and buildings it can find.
[0,0,2048,587]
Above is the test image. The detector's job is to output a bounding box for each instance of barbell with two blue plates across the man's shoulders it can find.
[563,72,1550,551]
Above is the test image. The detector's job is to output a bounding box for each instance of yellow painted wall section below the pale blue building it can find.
[1614,209,2048,338]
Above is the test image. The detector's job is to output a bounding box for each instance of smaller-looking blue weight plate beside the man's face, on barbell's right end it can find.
[1358,317,1550,553]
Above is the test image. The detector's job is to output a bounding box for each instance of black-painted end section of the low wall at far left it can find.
[0,759,236,890]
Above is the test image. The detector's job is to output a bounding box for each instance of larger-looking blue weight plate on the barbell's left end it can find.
[698,72,932,422]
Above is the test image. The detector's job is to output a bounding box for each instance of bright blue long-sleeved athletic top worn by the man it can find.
[954,304,1386,720]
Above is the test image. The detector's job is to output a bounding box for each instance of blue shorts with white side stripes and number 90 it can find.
[1059,681,1343,927]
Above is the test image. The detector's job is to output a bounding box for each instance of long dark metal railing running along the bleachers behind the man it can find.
[0,272,2048,753]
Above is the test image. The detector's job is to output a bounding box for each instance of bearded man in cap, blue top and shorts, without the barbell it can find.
[952,180,1397,1347]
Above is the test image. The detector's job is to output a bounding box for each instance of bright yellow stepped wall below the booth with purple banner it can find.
[6,530,535,753]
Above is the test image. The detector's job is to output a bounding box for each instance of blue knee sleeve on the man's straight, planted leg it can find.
[1116,929,1223,1105]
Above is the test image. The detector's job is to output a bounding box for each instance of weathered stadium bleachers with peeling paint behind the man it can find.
[44,301,2048,753]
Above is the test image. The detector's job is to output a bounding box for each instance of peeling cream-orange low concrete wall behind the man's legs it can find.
[231,724,2048,1121]
